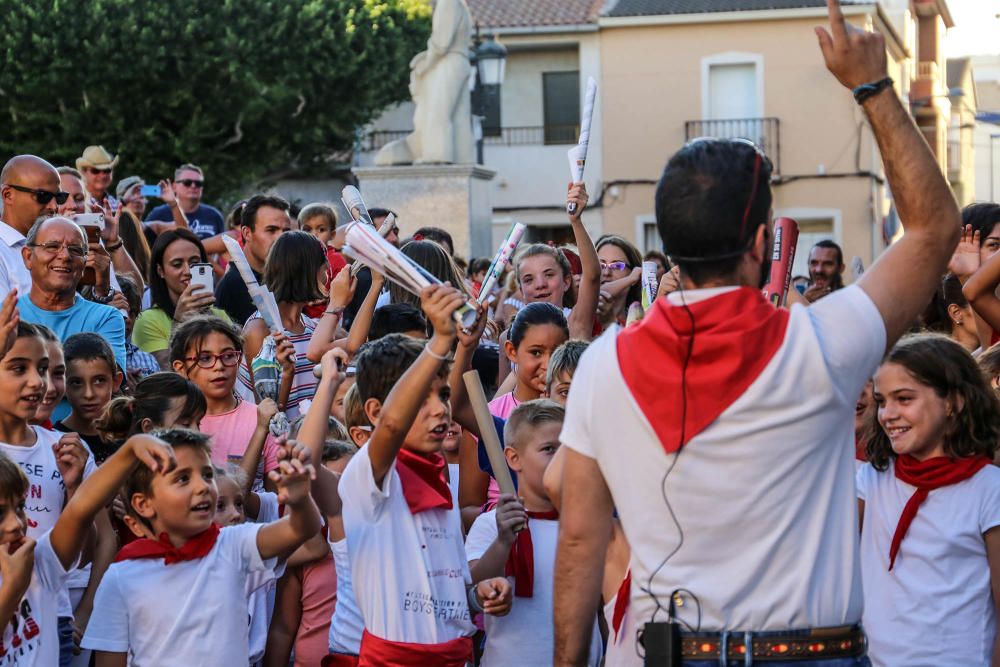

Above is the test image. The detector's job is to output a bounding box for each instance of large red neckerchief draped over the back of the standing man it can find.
[616,287,788,454]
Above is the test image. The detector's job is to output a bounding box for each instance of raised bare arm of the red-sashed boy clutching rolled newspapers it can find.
[368,285,465,486]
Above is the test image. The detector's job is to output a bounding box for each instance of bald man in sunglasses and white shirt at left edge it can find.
[0,155,63,294]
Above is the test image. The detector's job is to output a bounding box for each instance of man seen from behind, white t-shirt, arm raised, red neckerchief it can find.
[555,0,961,666]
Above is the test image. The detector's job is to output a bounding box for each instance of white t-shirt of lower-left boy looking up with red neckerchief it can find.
[83,523,275,667]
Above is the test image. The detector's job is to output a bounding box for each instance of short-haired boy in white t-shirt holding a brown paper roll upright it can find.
[465,399,601,667]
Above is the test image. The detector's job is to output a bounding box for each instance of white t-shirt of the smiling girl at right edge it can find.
[857,464,1000,667]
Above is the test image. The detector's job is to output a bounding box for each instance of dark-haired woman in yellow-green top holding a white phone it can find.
[132,229,229,368]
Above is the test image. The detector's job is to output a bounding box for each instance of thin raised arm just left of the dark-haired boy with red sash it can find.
[297,347,349,520]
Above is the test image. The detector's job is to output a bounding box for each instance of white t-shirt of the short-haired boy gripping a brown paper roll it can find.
[465,510,601,667]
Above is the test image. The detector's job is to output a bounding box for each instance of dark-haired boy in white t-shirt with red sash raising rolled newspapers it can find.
[339,285,511,667]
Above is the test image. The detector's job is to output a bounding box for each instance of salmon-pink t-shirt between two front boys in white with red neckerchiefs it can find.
[295,553,337,667]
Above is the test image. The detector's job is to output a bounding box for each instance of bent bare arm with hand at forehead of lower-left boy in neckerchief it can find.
[49,435,177,569]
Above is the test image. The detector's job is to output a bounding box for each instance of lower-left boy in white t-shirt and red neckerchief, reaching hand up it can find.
[83,429,320,667]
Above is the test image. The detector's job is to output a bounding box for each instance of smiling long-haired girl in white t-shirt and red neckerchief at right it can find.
[857,335,1000,667]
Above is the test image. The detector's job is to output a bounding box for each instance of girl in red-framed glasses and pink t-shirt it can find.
[170,315,277,488]
